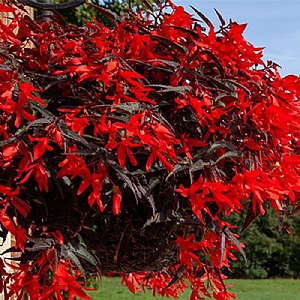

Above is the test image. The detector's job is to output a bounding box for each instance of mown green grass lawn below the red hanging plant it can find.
[85,277,300,300]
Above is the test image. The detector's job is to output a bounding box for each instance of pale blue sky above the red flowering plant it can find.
[173,0,300,76]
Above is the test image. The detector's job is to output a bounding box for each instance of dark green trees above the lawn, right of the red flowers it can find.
[228,209,300,279]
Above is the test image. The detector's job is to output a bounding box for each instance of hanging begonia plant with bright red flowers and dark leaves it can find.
[0,1,300,300]
